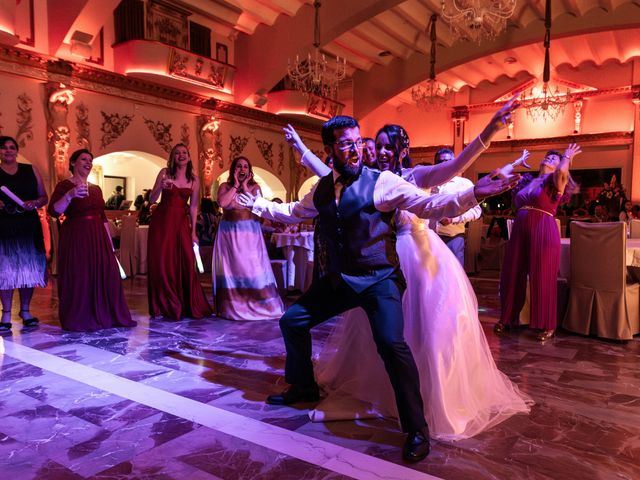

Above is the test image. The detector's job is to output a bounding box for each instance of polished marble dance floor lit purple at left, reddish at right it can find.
[0,277,640,480]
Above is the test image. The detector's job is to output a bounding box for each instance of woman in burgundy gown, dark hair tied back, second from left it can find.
[49,149,136,331]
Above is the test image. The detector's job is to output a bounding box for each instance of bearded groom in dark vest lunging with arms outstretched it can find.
[238,116,517,461]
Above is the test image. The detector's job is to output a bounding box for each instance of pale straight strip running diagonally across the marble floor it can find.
[0,338,441,480]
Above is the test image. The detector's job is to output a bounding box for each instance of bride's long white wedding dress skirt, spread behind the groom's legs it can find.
[309,208,533,440]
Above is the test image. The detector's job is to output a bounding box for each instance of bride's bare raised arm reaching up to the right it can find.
[413,93,520,188]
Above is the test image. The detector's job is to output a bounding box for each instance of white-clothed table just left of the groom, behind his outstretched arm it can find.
[271,232,313,291]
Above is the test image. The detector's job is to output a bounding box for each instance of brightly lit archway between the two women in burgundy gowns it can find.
[94,150,167,206]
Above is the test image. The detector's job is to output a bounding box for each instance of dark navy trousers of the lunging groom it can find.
[280,273,426,432]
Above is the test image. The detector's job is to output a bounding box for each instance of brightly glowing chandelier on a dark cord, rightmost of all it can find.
[522,0,571,122]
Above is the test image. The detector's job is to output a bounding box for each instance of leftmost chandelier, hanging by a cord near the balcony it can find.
[287,0,347,100]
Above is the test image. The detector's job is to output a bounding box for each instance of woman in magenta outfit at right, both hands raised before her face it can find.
[494,144,581,342]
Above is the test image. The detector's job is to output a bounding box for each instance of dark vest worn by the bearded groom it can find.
[313,167,404,292]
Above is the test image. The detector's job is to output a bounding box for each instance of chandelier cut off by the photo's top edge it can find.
[442,0,516,43]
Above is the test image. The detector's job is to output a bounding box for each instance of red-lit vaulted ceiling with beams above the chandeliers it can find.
[42,0,640,118]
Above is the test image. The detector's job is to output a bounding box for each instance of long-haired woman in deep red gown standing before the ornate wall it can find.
[147,143,212,320]
